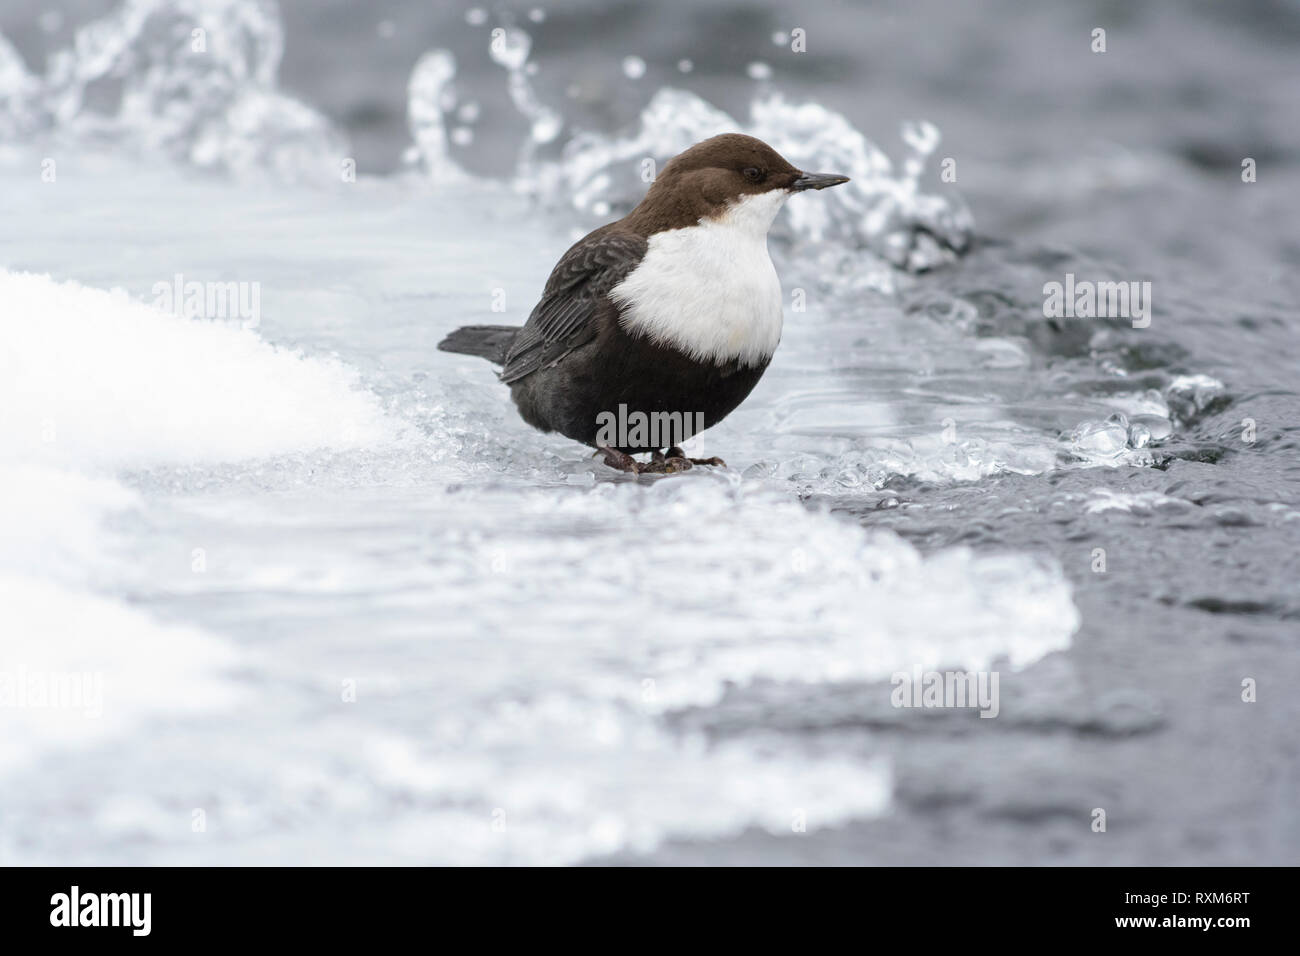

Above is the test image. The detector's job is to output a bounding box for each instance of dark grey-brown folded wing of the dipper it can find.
[501,224,646,384]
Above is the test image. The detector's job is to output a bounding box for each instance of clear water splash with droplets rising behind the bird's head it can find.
[411,20,974,272]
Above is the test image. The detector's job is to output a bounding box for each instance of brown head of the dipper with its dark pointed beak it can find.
[623,133,849,235]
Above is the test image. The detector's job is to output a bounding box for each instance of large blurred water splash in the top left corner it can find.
[0,0,348,179]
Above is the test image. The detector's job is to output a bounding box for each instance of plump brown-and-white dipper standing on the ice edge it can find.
[438,133,849,472]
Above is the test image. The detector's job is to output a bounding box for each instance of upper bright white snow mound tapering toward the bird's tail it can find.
[0,271,393,467]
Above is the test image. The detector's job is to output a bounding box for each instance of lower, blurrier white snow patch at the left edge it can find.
[0,462,239,770]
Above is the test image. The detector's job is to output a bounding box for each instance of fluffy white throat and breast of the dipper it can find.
[610,190,789,365]
